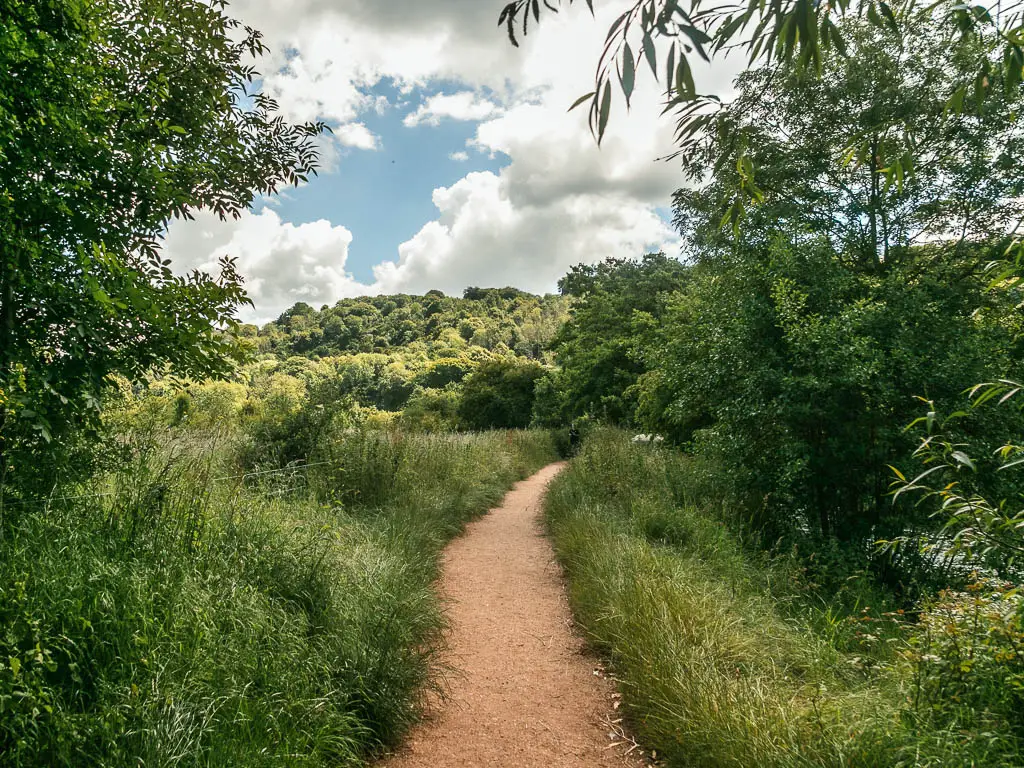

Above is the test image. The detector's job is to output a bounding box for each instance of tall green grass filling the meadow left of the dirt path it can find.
[0,423,554,767]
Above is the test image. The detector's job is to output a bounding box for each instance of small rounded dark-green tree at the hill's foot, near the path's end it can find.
[459,359,544,430]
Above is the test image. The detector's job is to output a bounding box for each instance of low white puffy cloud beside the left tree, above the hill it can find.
[164,209,367,322]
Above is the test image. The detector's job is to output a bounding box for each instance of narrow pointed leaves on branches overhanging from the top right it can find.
[499,0,1024,228]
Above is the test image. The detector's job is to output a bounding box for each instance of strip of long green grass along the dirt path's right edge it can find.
[547,430,1022,768]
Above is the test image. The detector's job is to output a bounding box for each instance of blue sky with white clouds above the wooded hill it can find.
[159,0,731,323]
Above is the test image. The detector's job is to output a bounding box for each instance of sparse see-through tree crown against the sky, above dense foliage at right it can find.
[676,19,1024,271]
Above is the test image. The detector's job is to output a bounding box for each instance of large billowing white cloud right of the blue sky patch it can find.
[358,5,704,292]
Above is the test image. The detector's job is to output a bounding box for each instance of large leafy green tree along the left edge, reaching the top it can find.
[0,0,325,480]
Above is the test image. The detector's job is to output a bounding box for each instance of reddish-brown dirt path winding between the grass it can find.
[380,464,636,768]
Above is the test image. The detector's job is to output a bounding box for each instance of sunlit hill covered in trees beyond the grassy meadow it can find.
[144,288,571,438]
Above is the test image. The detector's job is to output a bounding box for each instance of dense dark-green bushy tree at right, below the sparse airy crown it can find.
[641,241,1015,552]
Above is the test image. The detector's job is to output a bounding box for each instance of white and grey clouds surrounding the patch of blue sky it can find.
[168,0,735,319]
